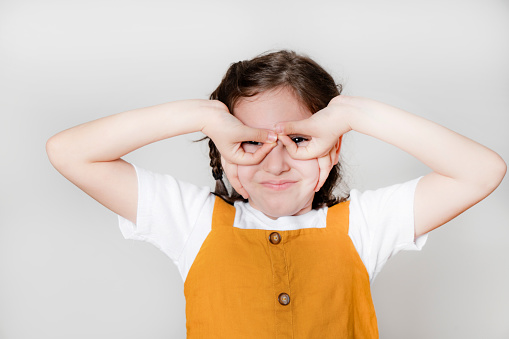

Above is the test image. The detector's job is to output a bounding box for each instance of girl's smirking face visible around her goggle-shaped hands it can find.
[232,88,319,219]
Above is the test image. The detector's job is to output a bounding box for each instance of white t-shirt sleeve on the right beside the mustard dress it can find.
[348,178,428,281]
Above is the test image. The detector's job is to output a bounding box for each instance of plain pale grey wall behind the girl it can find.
[0,0,509,339]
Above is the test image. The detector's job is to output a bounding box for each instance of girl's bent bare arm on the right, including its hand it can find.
[276,96,507,237]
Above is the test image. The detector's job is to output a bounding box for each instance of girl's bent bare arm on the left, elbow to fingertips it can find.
[46,100,276,222]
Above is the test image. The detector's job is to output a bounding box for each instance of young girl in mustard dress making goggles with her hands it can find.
[47,51,506,338]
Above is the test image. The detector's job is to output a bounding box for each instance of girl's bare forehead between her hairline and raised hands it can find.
[233,88,311,129]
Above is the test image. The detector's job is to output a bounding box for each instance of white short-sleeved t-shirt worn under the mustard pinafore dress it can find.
[119,166,427,281]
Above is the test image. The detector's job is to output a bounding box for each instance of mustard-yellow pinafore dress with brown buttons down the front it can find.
[184,198,378,339]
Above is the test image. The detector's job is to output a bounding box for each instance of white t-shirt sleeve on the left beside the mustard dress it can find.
[118,165,214,264]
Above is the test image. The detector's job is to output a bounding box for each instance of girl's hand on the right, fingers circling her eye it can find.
[275,96,354,192]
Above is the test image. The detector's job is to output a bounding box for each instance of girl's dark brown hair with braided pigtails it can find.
[209,50,349,209]
